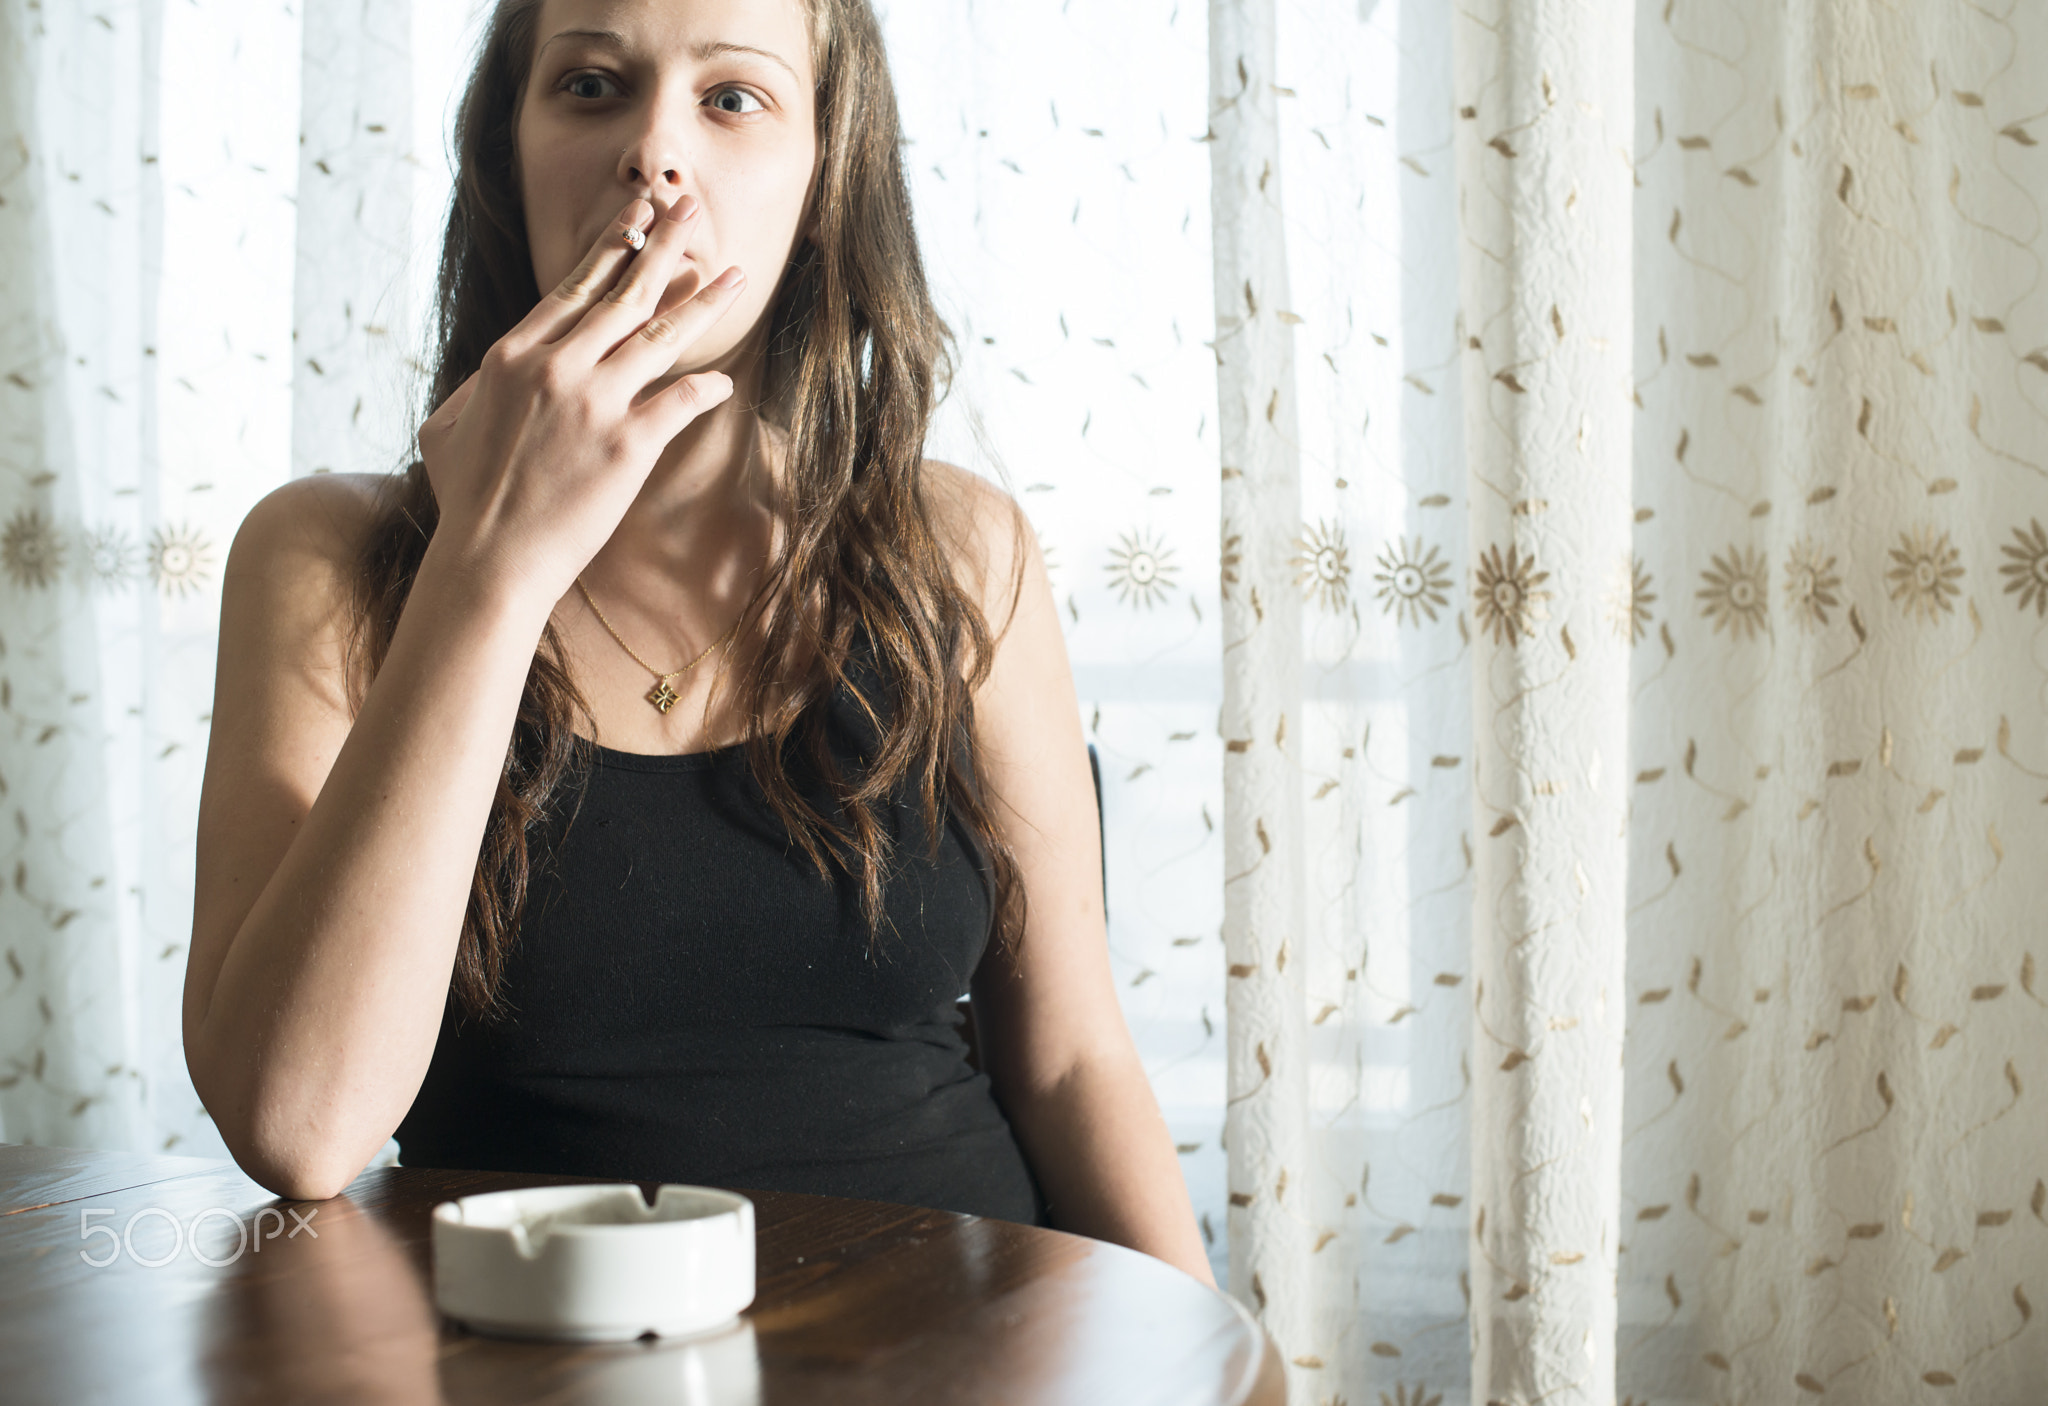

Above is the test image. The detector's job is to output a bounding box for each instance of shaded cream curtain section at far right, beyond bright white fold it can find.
[1616,0,2048,1402]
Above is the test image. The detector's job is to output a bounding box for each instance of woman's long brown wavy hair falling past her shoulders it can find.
[350,0,1024,1035]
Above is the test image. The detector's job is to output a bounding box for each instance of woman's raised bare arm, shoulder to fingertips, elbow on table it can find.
[184,199,739,1199]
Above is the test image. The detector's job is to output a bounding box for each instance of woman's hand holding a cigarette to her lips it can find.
[420,196,745,608]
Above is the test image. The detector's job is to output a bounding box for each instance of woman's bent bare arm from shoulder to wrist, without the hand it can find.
[184,479,549,1199]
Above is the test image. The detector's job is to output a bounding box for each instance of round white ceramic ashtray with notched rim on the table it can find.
[434,1181,754,1343]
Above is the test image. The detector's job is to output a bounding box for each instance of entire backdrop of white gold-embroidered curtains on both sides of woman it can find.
[0,0,2048,1406]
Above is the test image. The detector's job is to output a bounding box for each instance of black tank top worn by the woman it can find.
[397,654,1051,1226]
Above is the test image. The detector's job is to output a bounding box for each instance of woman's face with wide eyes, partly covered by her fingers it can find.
[514,0,817,372]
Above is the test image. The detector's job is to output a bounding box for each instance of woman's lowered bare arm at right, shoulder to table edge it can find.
[932,465,1214,1285]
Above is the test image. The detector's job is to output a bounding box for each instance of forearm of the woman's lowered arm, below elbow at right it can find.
[1004,1052,1217,1287]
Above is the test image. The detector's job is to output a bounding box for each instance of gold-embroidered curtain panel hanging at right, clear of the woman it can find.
[1208,0,2048,1406]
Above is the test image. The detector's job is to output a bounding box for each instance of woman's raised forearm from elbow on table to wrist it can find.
[186,548,547,1199]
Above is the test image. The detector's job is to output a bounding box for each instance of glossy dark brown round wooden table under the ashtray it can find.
[0,1144,1286,1406]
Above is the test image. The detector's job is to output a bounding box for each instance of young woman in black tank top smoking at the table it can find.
[184,0,1210,1281]
